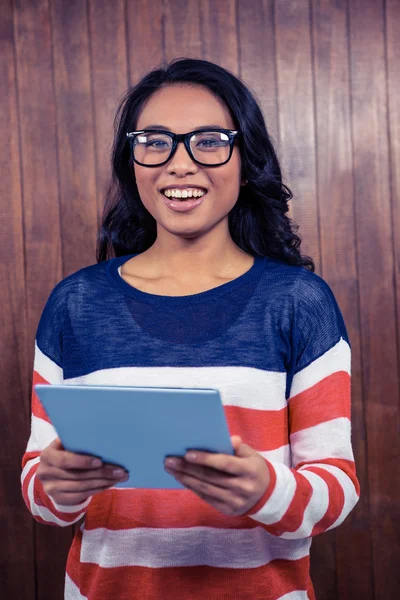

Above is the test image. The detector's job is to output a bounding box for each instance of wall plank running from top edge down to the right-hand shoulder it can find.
[274,0,321,272]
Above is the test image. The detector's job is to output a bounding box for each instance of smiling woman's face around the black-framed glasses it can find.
[134,84,241,238]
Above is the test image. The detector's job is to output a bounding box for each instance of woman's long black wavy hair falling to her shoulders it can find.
[97,58,315,271]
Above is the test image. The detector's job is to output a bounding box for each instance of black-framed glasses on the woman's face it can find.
[126,129,239,167]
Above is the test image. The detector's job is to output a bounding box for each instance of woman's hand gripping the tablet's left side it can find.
[37,438,128,506]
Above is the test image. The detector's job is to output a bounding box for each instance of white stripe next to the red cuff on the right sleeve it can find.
[250,463,297,525]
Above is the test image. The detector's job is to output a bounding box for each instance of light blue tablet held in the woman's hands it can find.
[35,384,234,489]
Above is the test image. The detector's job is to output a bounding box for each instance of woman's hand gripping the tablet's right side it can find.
[165,436,270,516]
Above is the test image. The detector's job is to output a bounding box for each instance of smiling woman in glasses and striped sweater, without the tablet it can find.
[22,59,359,600]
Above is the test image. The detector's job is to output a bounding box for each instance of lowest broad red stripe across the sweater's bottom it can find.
[67,531,313,600]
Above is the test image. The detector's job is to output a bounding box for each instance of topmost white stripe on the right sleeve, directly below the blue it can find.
[290,338,351,398]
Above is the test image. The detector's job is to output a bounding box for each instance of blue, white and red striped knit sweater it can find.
[21,256,359,600]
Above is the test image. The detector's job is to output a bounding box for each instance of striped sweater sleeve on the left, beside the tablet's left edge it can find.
[21,284,90,527]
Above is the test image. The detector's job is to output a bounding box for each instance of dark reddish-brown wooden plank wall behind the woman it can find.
[0,0,400,600]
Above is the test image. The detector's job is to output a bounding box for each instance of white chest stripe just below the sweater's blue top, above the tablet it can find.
[64,367,287,410]
